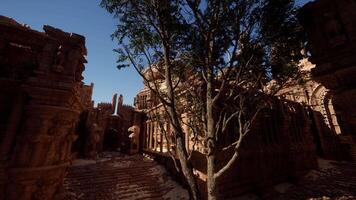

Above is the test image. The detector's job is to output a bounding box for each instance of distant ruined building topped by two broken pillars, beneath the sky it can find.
[72,94,143,158]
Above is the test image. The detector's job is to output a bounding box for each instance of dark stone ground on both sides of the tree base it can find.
[65,153,356,200]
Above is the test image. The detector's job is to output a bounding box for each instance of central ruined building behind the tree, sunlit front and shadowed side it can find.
[135,67,316,198]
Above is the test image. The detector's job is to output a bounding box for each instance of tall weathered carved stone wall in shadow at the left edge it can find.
[0,16,86,200]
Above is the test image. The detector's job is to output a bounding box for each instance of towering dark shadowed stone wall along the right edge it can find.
[300,0,356,160]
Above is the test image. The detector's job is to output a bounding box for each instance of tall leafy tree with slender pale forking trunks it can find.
[101,0,303,199]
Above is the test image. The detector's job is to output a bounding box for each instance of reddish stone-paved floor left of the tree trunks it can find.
[65,153,188,200]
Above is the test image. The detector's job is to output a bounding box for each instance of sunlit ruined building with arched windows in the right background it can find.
[277,59,349,160]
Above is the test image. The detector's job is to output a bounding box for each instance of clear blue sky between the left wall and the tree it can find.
[0,0,309,104]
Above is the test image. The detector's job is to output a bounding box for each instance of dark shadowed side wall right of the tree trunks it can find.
[214,99,317,199]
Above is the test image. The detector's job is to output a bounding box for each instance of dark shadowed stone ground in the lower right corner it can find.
[270,159,356,200]
